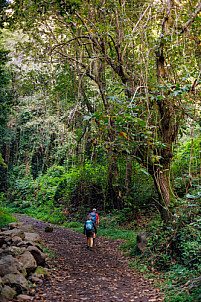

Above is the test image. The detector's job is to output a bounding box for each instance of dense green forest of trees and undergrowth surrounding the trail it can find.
[0,0,201,301]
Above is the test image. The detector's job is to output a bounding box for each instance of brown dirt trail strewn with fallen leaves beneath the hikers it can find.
[14,214,163,302]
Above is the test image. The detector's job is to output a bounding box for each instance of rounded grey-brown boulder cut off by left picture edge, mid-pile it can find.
[0,255,19,277]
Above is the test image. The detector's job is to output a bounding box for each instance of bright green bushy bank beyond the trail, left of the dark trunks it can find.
[8,162,105,224]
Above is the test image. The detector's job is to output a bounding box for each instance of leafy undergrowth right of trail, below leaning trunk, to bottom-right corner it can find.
[114,201,201,302]
